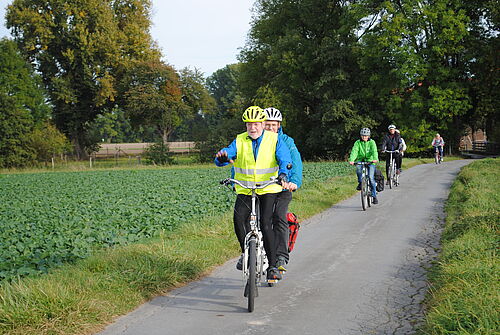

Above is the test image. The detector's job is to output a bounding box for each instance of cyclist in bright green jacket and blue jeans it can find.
[349,128,378,205]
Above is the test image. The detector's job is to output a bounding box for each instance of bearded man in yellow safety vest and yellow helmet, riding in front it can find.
[214,106,292,279]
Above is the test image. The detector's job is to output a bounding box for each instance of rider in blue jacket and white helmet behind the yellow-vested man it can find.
[264,107,302,272]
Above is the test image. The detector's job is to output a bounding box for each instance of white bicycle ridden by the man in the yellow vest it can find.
[220,177,279,312]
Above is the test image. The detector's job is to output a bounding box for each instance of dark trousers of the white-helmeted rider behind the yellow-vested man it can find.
[273,191,292,263]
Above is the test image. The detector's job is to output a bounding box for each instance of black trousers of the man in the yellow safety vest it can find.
[233,193,277,266]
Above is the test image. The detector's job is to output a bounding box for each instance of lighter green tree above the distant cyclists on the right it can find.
[363,0,472,150]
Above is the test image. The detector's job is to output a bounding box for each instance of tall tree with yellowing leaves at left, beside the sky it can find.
[6,0,158,156]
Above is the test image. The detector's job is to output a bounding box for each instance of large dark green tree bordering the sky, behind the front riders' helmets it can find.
[240,0,374,157]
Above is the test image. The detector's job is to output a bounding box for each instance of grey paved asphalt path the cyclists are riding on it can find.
[100,160,470,335]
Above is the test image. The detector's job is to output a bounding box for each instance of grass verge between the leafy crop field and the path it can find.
[0,159,460,335]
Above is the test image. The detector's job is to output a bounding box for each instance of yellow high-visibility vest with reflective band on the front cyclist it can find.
[234,131,282,195]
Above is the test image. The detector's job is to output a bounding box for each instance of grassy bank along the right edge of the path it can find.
[420,159,500,335]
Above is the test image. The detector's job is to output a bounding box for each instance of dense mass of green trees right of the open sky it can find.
[236,0,500,158]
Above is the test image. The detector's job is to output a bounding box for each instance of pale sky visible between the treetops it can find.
[0,0,254,76]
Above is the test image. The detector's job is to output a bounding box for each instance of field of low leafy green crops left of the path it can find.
[0,162,354,281]
